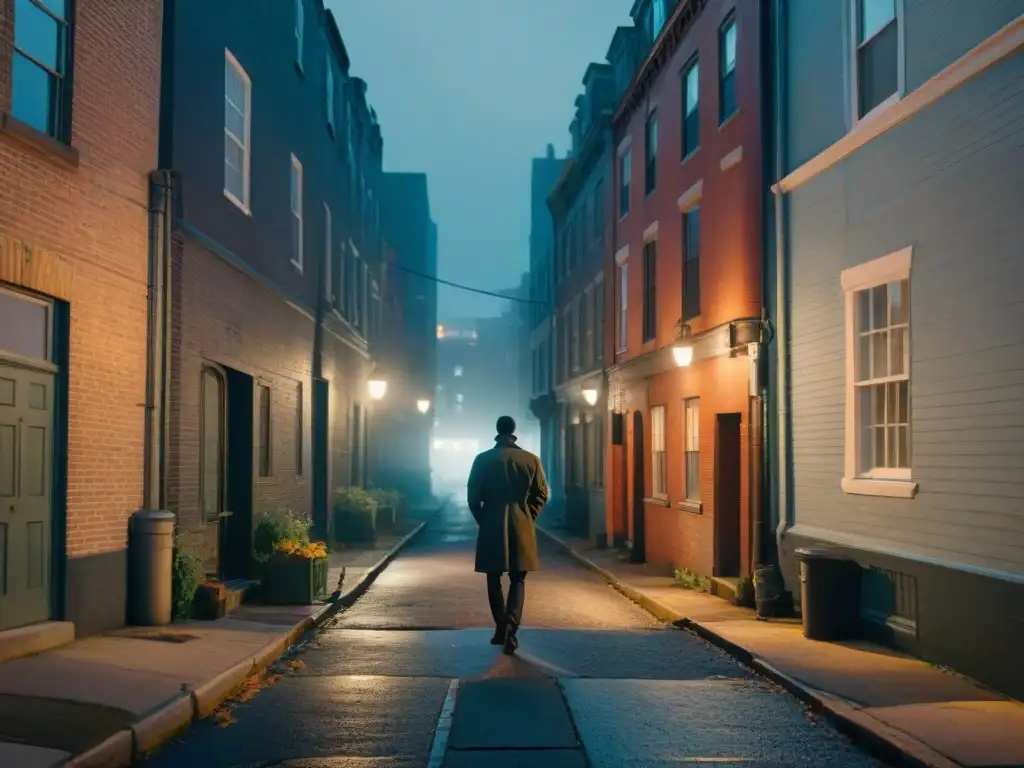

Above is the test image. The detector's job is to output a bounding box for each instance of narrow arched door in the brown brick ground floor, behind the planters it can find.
[199,366,227,579]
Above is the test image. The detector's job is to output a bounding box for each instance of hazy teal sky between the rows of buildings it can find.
[326,0,633,322]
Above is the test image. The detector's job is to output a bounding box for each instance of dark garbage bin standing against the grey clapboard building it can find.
[797,548,860,640]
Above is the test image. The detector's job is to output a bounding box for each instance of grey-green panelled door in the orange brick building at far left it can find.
[0,364,55,630]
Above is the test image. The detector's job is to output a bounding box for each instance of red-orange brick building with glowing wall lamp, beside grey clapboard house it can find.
[605,0,763,578]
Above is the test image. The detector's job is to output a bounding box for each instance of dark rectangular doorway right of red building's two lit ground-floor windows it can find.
[715,414,740,578]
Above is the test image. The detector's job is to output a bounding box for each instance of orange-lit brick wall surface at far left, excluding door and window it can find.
[0,0,162,565]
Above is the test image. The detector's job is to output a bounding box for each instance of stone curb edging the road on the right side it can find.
[537,525,963,768]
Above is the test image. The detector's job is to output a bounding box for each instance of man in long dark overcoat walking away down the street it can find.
[467,416,550,655]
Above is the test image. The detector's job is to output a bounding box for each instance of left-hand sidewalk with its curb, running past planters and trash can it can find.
[0,500,443,768]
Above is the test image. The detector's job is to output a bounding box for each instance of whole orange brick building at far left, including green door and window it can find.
[0,0,161,634]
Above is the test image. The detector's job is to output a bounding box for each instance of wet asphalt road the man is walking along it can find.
[145,505,880,768]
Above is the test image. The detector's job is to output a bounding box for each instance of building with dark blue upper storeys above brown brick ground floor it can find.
[161,0,383,581]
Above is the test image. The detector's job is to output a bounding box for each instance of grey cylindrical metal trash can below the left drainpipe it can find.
[128,509,174,627]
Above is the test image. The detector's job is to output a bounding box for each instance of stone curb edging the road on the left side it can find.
[63,497,450,768]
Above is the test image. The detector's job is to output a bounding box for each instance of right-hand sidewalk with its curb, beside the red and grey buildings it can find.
[542,529,1024,768]
